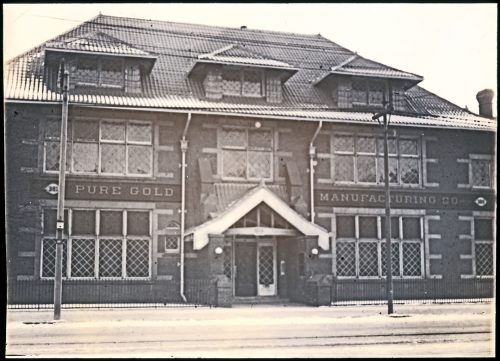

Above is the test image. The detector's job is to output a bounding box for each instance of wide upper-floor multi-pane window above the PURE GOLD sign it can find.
[44,120,153,176]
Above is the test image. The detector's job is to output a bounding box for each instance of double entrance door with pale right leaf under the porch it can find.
[233,239,277,297]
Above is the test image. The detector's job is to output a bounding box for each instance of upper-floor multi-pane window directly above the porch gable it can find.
[219,128,273,180]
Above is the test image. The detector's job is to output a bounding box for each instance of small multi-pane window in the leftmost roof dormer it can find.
[74,57,125,89]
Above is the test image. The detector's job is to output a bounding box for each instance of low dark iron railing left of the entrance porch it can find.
[7,280,216,309]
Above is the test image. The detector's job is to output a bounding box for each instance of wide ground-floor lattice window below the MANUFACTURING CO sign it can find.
[336,215,424,278]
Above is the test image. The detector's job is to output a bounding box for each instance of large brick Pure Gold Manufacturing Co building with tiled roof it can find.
[4,15,497,305]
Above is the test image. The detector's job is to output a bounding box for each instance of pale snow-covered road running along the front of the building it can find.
[6,304,494,358]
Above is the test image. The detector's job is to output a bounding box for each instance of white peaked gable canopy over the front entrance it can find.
[185,183,330,250]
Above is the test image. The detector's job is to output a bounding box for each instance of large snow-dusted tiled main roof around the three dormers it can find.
[4,15,496,130]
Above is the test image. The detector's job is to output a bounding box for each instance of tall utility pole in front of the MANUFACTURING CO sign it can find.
[372,82,394,314]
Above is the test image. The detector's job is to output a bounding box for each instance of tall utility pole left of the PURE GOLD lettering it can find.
[54,60,69,320]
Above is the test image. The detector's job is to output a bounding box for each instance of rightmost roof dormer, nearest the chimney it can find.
[313,54,423,110]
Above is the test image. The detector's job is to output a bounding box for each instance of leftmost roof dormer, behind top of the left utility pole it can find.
[45,32,156,94]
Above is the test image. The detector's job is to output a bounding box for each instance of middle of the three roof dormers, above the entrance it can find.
[188,44,298,103]
